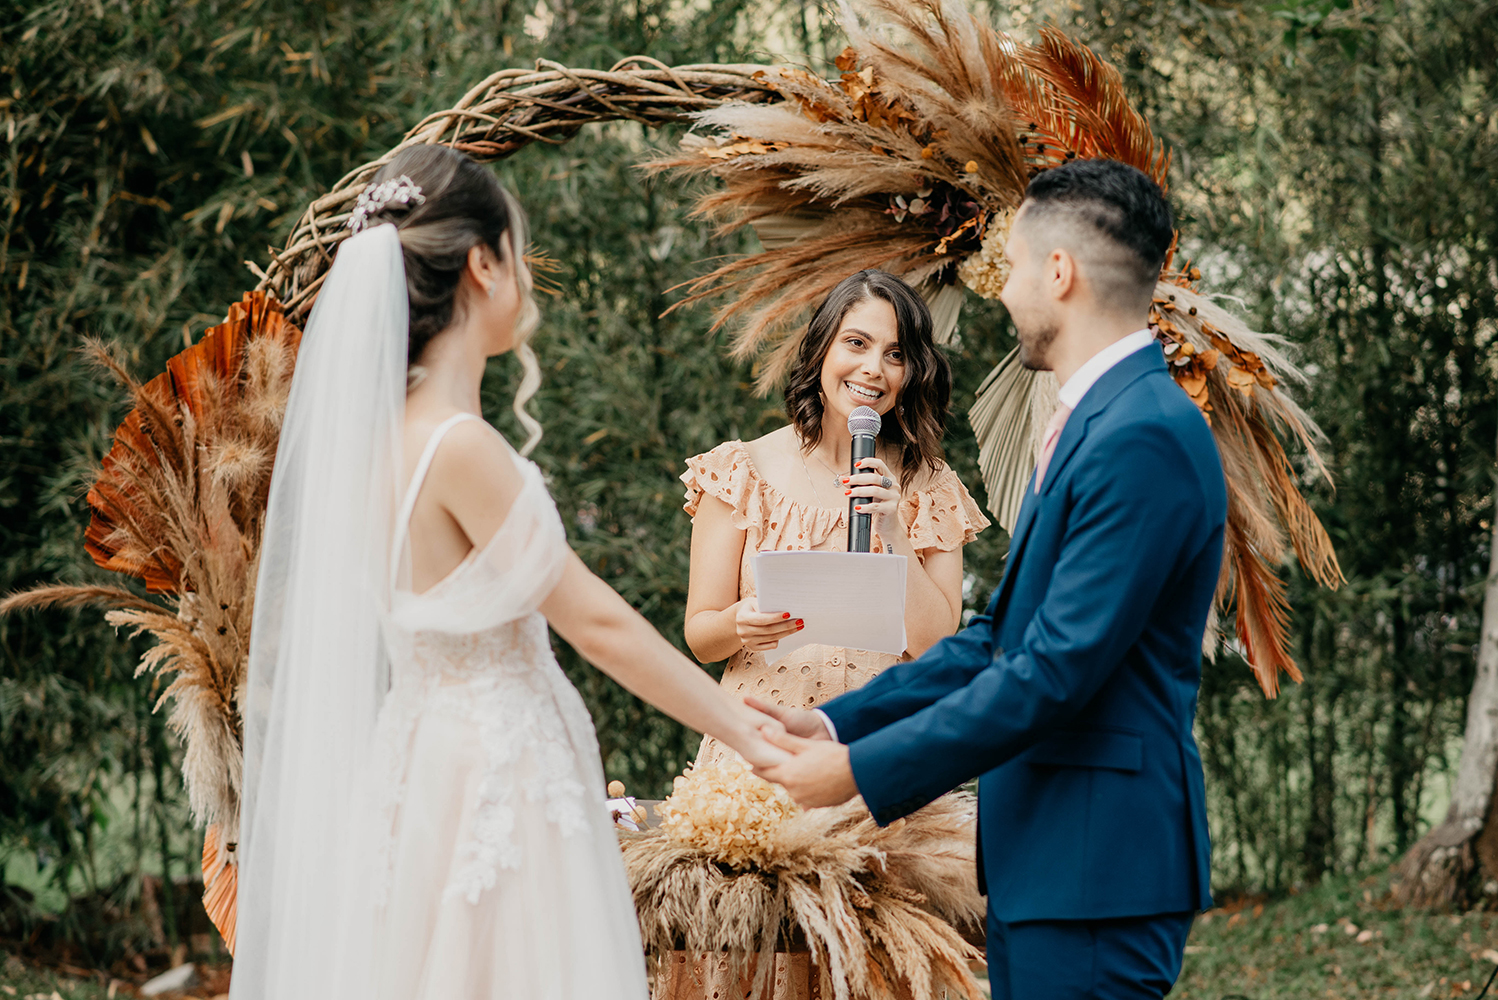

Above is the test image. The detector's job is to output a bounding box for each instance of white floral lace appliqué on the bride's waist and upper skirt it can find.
[371,614,601,903]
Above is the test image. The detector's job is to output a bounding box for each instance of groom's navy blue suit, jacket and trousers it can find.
[822,346,1227,1000]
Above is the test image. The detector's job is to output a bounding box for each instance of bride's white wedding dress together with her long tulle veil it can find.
[235,225,646,1000]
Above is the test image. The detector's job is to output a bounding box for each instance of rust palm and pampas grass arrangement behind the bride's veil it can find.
[0,292,301,952]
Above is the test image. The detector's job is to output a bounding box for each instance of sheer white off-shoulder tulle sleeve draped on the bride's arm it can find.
[392,458,568,633]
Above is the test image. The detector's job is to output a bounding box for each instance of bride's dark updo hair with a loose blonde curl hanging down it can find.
[366,145,541,455]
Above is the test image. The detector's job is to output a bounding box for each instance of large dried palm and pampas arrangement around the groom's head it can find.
[650,0,1342,698]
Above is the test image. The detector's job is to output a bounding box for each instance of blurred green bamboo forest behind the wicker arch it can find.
[0,0,1498,970]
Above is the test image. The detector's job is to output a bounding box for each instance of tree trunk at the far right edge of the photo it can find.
[1395,470,1498,907]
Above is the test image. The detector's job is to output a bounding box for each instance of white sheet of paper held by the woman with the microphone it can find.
[753,552,905,656]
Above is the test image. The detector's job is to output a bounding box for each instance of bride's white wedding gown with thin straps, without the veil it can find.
[375,413,646,1000]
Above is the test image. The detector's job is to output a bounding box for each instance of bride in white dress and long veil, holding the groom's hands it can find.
[231,145,783,1000]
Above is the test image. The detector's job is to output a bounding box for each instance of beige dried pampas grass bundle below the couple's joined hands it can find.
[620,792,986,1000]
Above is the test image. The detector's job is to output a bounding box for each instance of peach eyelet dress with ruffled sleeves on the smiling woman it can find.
[653,440,989,1000]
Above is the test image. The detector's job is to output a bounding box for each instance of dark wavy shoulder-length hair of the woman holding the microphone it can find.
[785,268,951,488]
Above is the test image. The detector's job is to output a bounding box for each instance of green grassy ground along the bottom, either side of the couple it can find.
[0,876,1498,1000]
